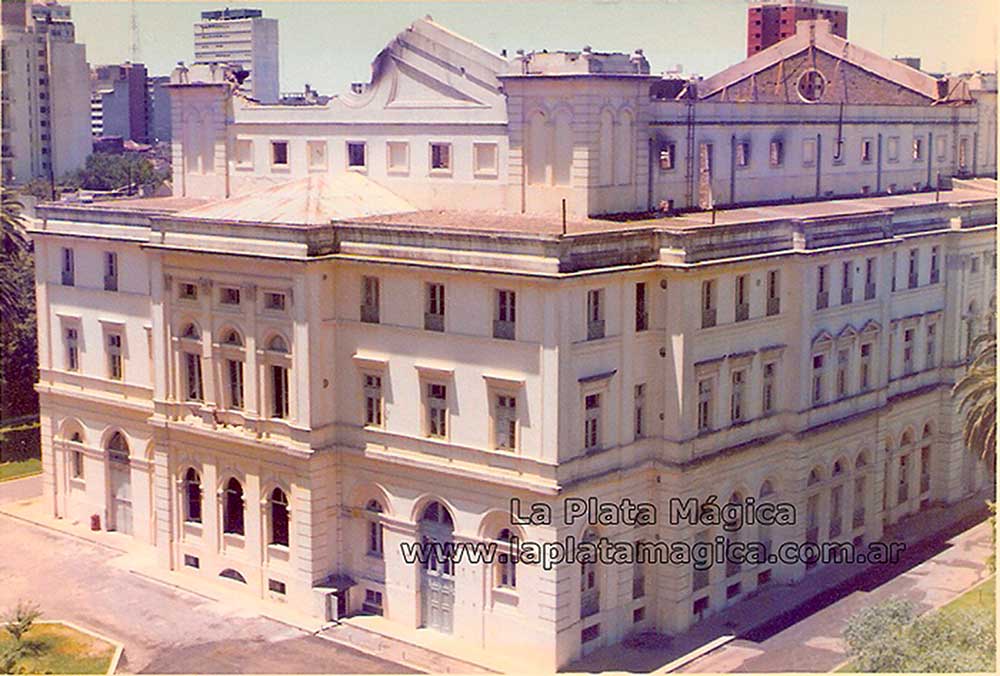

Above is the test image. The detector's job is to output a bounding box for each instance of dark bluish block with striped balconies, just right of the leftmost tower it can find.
[90,63,151,143]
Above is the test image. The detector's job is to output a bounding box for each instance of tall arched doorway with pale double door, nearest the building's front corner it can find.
[419,501,455,634]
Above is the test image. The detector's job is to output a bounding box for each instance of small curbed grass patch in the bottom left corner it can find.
[0,624,115,674]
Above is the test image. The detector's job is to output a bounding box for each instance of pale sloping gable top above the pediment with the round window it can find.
[698,19,954,101]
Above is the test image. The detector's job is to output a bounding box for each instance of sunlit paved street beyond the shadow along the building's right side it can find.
[680,523,991,673]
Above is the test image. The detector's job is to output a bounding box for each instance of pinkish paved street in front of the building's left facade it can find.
[0,512,412,673]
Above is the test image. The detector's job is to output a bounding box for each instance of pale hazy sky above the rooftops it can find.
[64,0,997,94]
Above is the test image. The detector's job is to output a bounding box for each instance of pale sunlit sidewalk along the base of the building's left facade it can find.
[0,496,496,674]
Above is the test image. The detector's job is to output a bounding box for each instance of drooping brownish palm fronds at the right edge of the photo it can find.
[952,333,997,460]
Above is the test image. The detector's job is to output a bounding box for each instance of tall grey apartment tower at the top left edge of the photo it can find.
[2,0,91,183]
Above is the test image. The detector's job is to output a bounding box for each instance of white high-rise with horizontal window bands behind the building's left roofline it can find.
[194,8,279,103]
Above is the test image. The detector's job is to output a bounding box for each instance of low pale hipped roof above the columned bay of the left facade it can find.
[178,172,414,225]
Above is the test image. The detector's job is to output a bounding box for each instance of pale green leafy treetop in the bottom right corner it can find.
[844,599,996,673]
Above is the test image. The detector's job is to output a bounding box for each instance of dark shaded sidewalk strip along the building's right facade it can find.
[565,491,993,673]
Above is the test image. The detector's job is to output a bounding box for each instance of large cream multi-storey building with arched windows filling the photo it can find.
[33,15,996,670]
